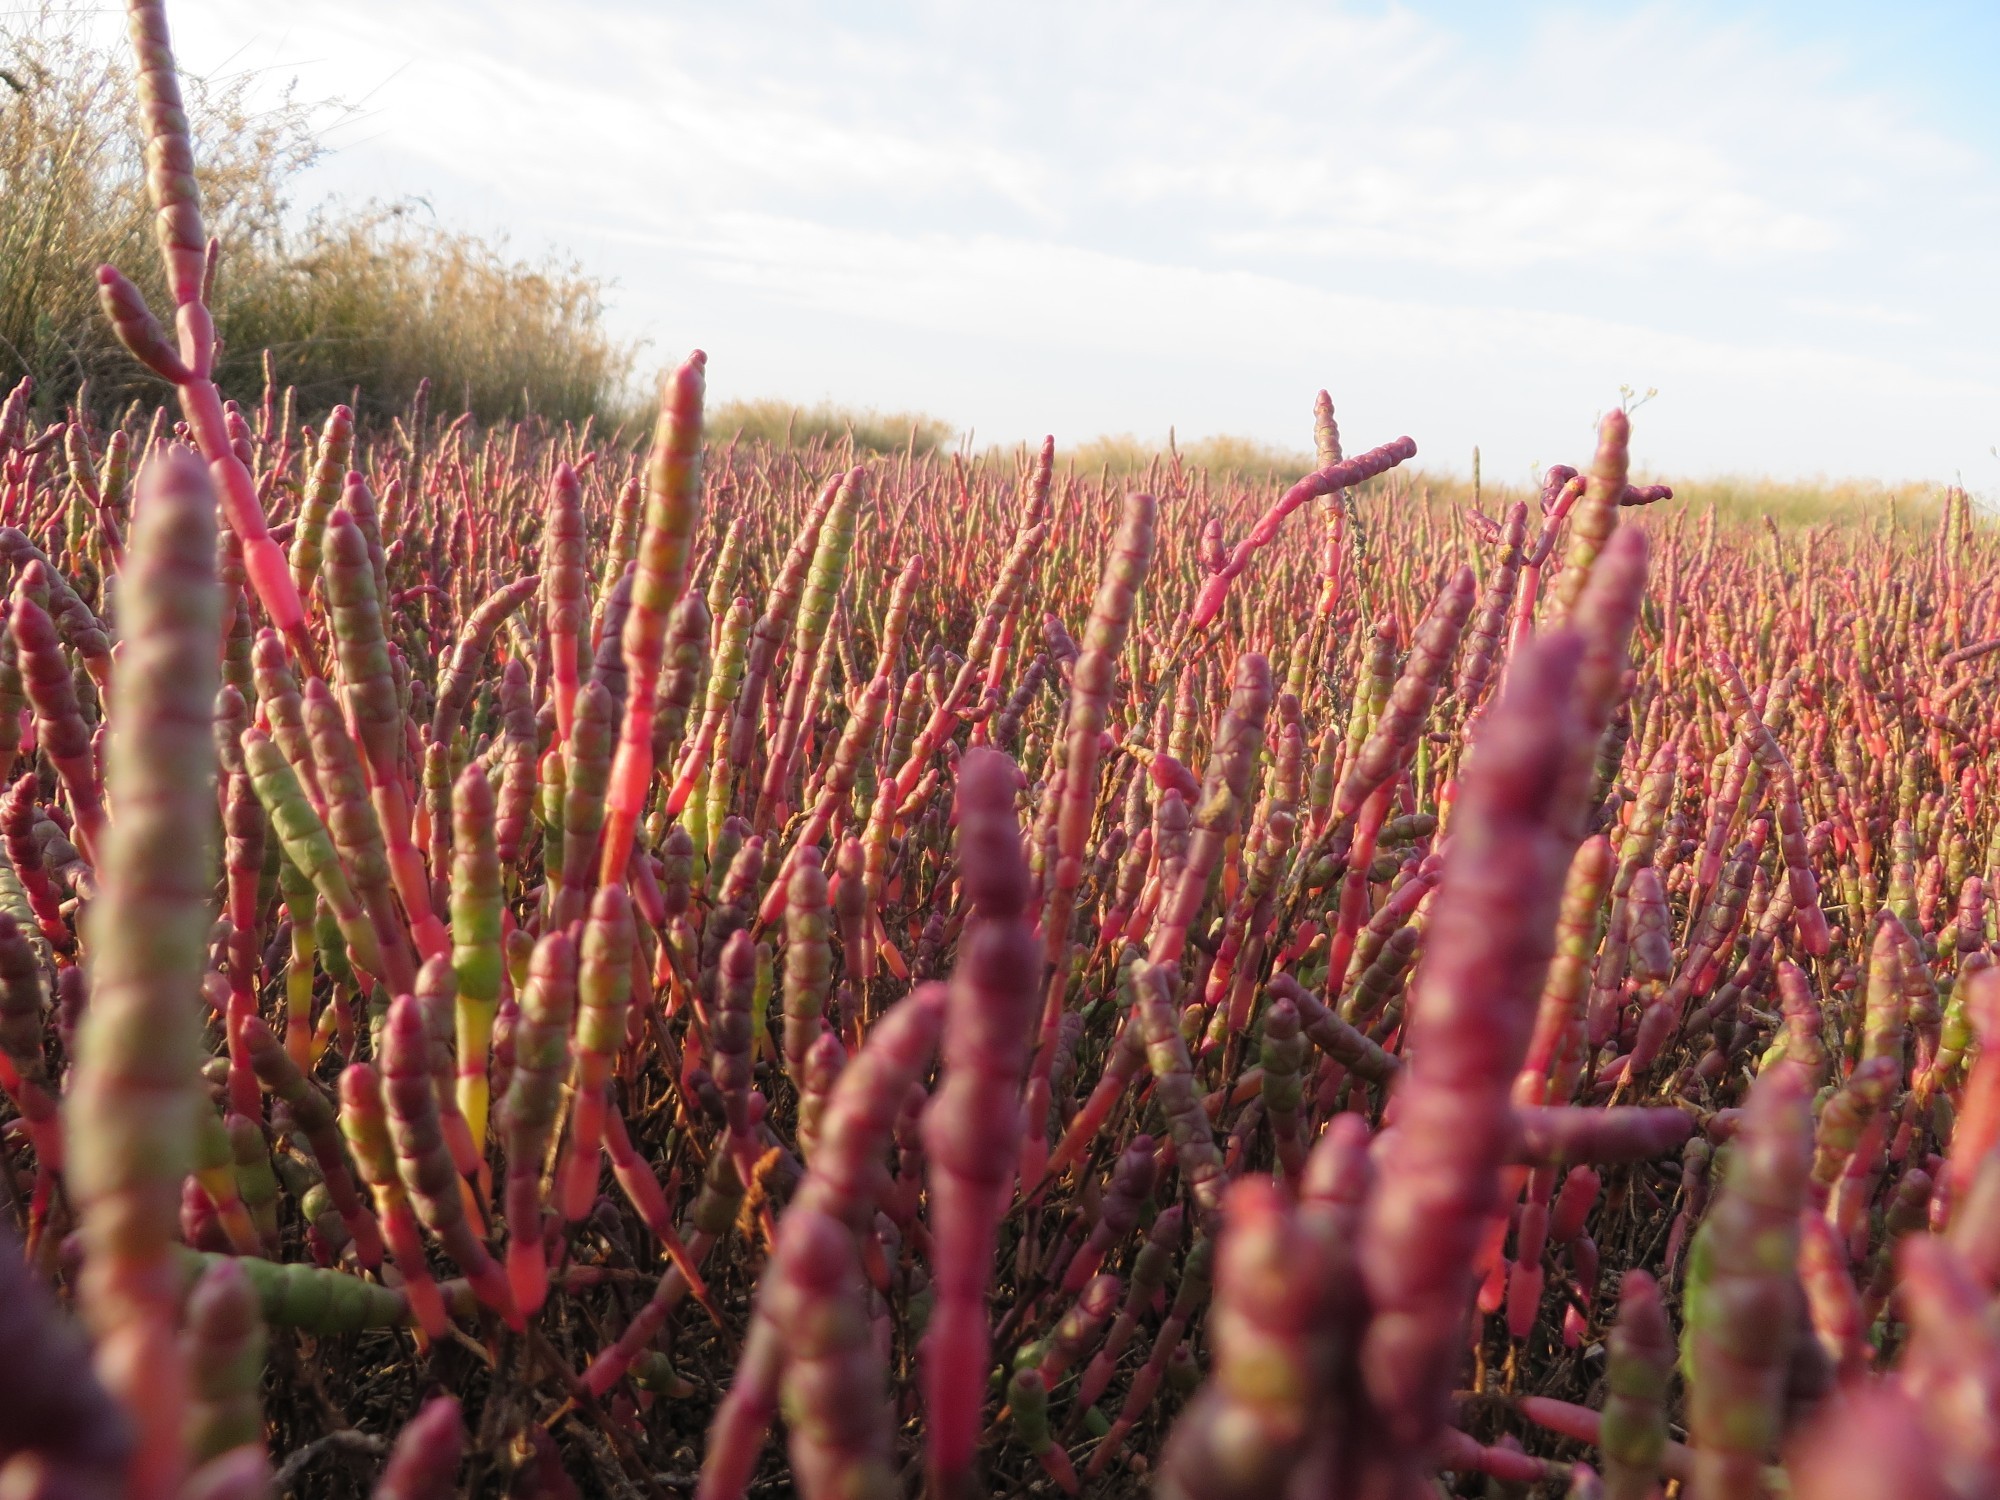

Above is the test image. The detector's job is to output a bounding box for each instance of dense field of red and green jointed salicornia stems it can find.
[0,0,2000,1500]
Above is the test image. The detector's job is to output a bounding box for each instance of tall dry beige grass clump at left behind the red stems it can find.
[0,0,634,420]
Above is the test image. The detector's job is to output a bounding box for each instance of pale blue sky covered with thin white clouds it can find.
[101,0,2000,496]
